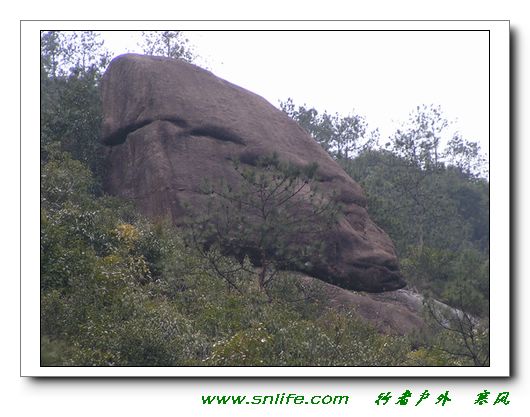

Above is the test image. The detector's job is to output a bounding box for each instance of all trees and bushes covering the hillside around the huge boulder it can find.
[40,32,489,366]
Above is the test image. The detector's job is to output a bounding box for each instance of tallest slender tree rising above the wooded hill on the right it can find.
[378,104,472,253]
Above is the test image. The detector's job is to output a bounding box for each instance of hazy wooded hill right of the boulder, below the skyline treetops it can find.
[343,146,489,344]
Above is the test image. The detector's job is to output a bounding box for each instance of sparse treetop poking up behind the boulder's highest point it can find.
[139,30,196,62]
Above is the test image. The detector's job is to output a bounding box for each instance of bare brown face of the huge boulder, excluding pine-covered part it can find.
[102,54,405,292]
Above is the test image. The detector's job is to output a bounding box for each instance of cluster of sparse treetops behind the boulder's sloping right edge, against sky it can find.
[280,98,379,159]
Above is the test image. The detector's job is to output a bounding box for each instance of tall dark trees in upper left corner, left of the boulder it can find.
[40,31,110,188]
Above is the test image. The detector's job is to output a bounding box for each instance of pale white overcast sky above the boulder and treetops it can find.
[101,31,489,154]
